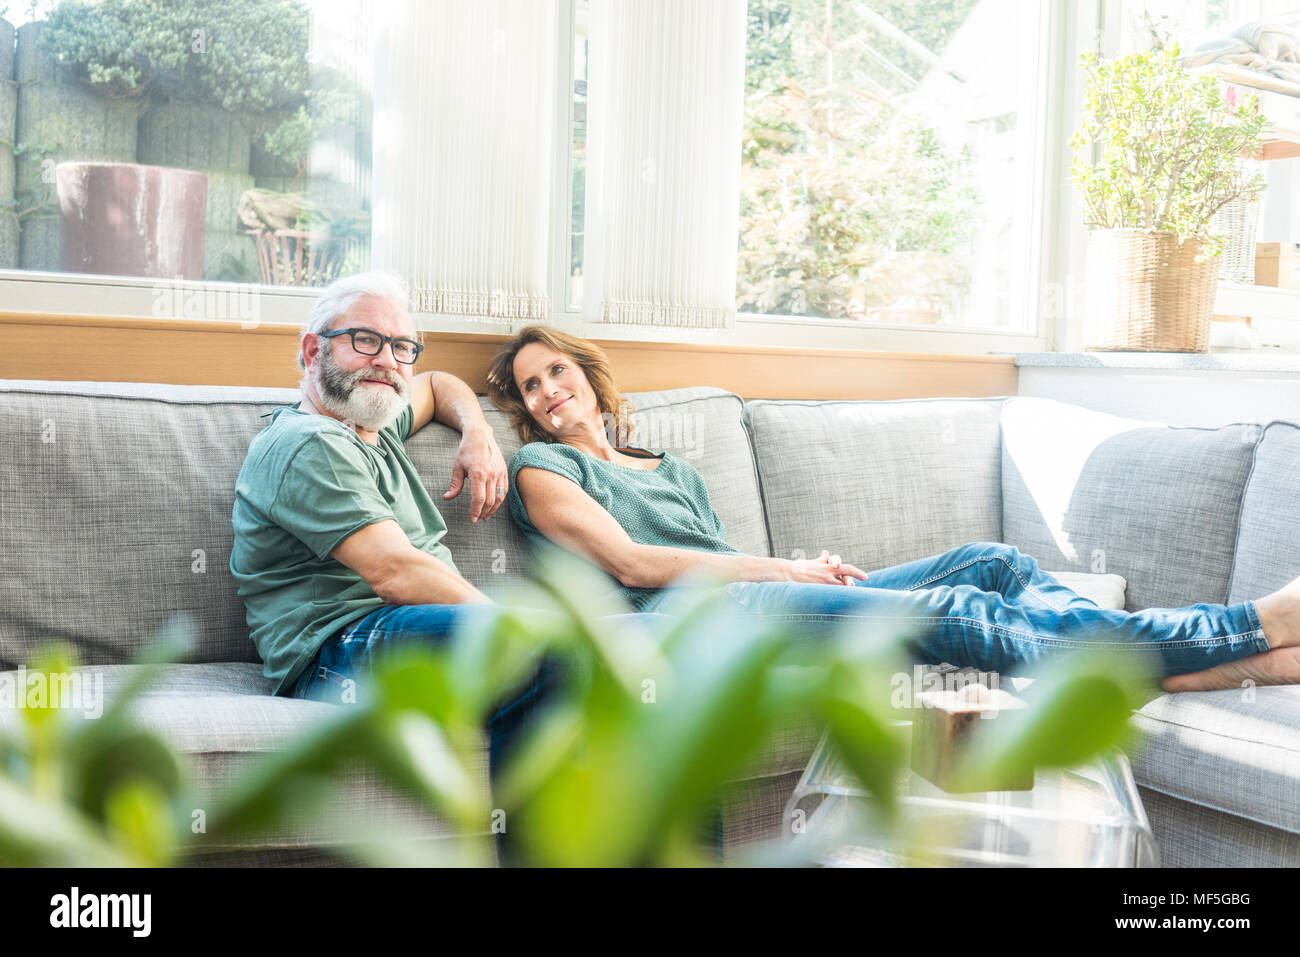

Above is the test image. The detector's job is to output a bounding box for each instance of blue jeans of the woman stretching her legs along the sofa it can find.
[647,542,1269,676]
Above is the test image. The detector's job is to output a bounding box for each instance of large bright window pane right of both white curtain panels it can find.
[737,0,1047,330]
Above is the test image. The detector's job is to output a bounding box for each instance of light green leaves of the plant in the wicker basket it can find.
[1070,43,1265,259]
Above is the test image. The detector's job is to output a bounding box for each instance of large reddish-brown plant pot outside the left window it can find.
[55,163,208,280]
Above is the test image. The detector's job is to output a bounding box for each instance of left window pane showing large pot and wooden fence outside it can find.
[0,0,372,291]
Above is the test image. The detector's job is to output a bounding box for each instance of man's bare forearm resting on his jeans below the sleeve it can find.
[329,519,490,605]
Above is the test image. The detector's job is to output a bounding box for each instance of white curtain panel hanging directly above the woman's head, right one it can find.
[584,0,745,328]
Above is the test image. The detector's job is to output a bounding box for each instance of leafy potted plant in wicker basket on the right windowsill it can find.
[1070,44,1265,352]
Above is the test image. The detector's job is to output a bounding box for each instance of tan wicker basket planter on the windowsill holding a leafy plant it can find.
[1088,229,1221,352]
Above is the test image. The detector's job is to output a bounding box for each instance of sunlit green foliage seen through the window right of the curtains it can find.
[737,0,979,319]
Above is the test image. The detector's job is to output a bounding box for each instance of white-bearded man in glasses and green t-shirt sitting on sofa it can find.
[230,273,507,702]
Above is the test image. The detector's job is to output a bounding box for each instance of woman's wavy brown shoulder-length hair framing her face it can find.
[488,325,633,446]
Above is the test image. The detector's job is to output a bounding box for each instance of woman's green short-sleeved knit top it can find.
[510,442,742,611]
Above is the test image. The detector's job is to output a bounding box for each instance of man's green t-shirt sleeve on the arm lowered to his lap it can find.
[270,433,394,559]
